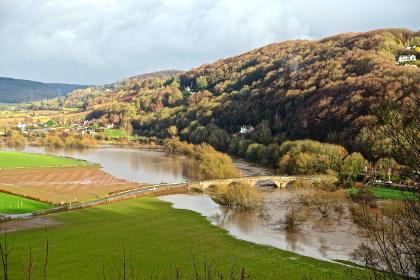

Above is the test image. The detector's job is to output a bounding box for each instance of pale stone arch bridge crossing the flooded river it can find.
[196,176,325,190]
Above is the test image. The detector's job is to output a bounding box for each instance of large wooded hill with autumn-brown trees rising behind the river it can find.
[35,29,420,168]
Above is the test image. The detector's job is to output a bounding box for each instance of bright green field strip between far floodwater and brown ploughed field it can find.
[0,151,89,168]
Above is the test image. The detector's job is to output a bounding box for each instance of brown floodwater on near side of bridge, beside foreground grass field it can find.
[159,188,362,260]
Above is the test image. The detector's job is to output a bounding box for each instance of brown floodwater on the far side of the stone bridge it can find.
[1,145,275,184]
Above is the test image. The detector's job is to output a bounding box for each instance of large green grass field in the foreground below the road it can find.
[0,197,349,280]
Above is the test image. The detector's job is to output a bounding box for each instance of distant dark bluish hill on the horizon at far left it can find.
[0,77,89,103]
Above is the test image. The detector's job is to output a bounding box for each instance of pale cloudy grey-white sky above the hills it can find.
[0,0,420,85]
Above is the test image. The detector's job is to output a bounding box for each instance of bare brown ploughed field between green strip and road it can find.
[0,167,148,203]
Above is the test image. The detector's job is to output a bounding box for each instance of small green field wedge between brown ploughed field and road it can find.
[0,192,54,214]
